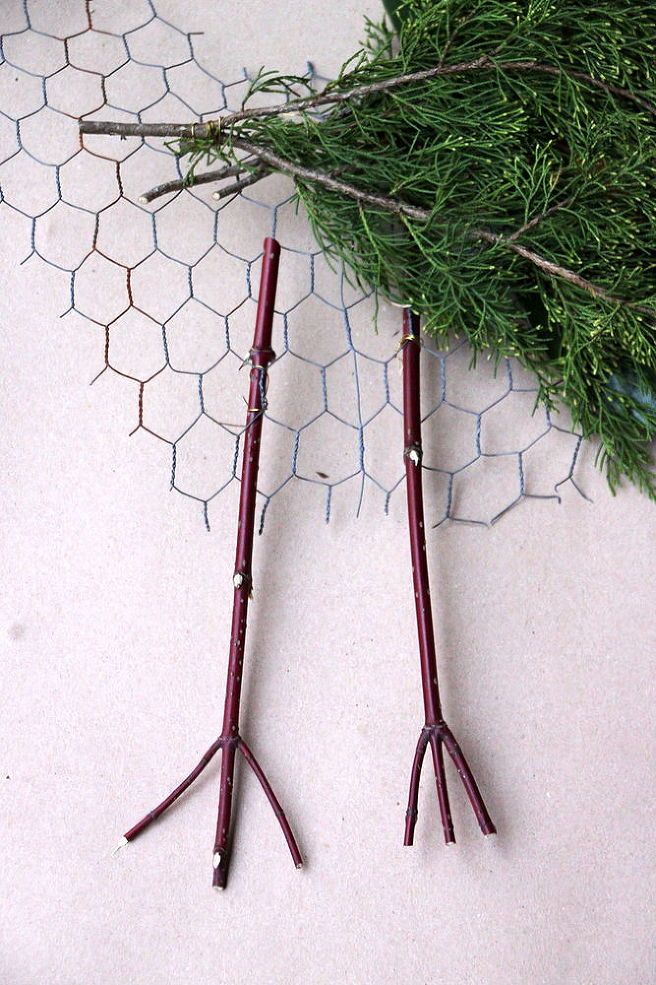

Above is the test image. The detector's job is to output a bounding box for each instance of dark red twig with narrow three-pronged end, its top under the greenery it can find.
[402,309,496,845]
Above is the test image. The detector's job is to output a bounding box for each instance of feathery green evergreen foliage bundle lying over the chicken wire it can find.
[170,0,656,496]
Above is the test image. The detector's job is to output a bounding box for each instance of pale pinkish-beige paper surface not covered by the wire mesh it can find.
[0,0,656,985]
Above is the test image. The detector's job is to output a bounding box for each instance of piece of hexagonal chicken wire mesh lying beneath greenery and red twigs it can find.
[0,0,581,527]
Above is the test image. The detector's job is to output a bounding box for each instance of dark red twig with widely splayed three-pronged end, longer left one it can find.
[118,238,303,889]
